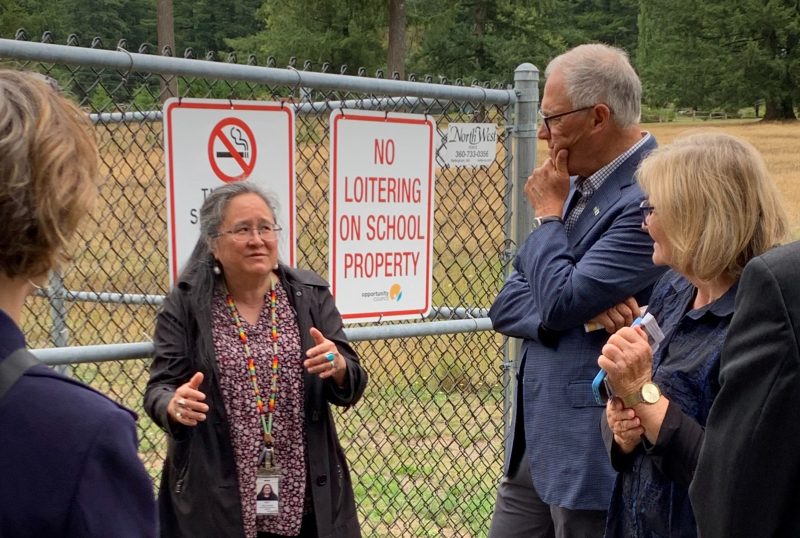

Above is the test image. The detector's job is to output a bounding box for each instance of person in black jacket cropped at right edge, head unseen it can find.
[689,242,800,538]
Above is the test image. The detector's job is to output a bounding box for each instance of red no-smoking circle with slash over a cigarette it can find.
[208,117,257,183]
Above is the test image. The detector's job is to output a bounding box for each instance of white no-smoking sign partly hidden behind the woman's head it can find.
[163,98,295,284]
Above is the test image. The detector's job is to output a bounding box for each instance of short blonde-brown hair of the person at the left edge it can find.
[0,70,98,278]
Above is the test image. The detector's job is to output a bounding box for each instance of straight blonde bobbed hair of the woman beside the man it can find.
[638,133,787,280]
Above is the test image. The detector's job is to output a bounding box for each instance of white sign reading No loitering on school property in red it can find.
[329,110,436,323]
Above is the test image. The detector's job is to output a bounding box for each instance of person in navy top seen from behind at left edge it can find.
[0,71,156,538]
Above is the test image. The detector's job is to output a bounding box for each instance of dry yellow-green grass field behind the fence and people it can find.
[20,115,800,537]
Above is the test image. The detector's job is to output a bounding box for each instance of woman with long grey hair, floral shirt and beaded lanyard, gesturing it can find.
[144,182,367,538]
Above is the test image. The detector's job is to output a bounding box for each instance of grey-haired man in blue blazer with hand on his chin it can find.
[489,45,663,538]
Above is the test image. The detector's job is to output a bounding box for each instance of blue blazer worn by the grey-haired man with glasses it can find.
[489,138,665,510]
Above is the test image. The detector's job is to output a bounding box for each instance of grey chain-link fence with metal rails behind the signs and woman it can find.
[0,33,538,536]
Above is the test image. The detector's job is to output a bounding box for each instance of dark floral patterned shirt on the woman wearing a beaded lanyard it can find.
[212,284,307,538]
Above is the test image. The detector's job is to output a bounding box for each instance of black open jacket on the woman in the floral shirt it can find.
[144,266,367,538]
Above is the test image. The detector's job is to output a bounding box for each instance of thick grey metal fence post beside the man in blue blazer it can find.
[503,63,539,451]
